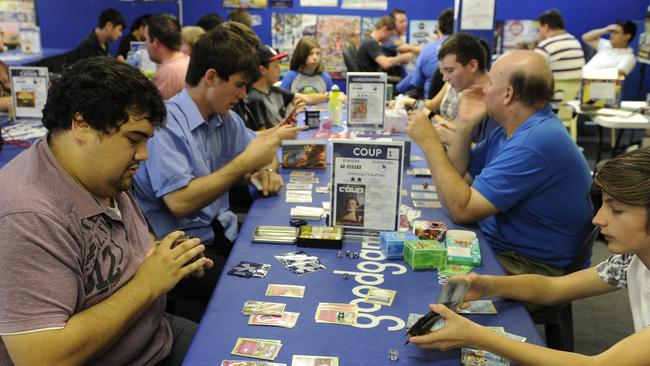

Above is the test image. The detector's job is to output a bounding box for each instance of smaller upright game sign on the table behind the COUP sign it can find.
[346,72,386,130]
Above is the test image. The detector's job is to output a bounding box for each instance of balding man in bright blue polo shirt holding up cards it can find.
[409,51,593,275]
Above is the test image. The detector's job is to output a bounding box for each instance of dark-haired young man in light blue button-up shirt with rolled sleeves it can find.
[134,28,282,299]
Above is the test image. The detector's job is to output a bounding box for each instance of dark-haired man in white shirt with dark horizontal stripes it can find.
[535,9,585,81]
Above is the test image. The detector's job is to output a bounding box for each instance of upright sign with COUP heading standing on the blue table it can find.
[330,140,404,233]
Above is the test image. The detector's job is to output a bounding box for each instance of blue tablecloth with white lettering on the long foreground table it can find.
[184,137,544,366]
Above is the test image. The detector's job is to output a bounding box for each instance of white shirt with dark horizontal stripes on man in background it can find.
[535,33,585,80]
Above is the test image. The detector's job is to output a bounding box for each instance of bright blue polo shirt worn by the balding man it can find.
[468,105,593,268]
